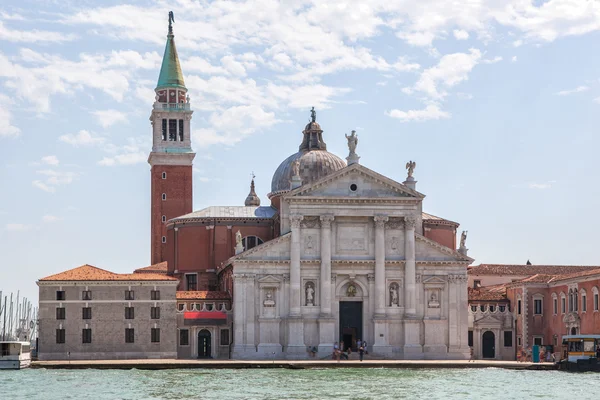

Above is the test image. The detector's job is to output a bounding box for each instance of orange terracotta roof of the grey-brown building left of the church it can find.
[40,264,178,281]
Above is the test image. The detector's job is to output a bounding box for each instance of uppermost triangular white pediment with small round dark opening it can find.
[286,164,425,201]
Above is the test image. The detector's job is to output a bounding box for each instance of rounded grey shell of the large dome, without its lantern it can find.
[271,150,346,195]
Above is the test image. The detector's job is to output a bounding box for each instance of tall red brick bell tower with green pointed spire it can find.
[148,12,196,264]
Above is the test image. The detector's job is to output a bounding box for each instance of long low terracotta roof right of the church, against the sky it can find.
[467,264,600,276]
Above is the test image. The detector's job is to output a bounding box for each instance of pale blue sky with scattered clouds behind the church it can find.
[0,0,600,299]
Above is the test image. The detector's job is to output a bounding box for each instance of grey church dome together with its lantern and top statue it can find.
[269,107,346,197]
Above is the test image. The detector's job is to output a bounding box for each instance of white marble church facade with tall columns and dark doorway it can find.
[230,164,471,359]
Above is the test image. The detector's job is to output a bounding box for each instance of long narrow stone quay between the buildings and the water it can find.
[31,359,557,371]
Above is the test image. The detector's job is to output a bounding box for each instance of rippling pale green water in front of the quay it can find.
[0,368,600,400]
